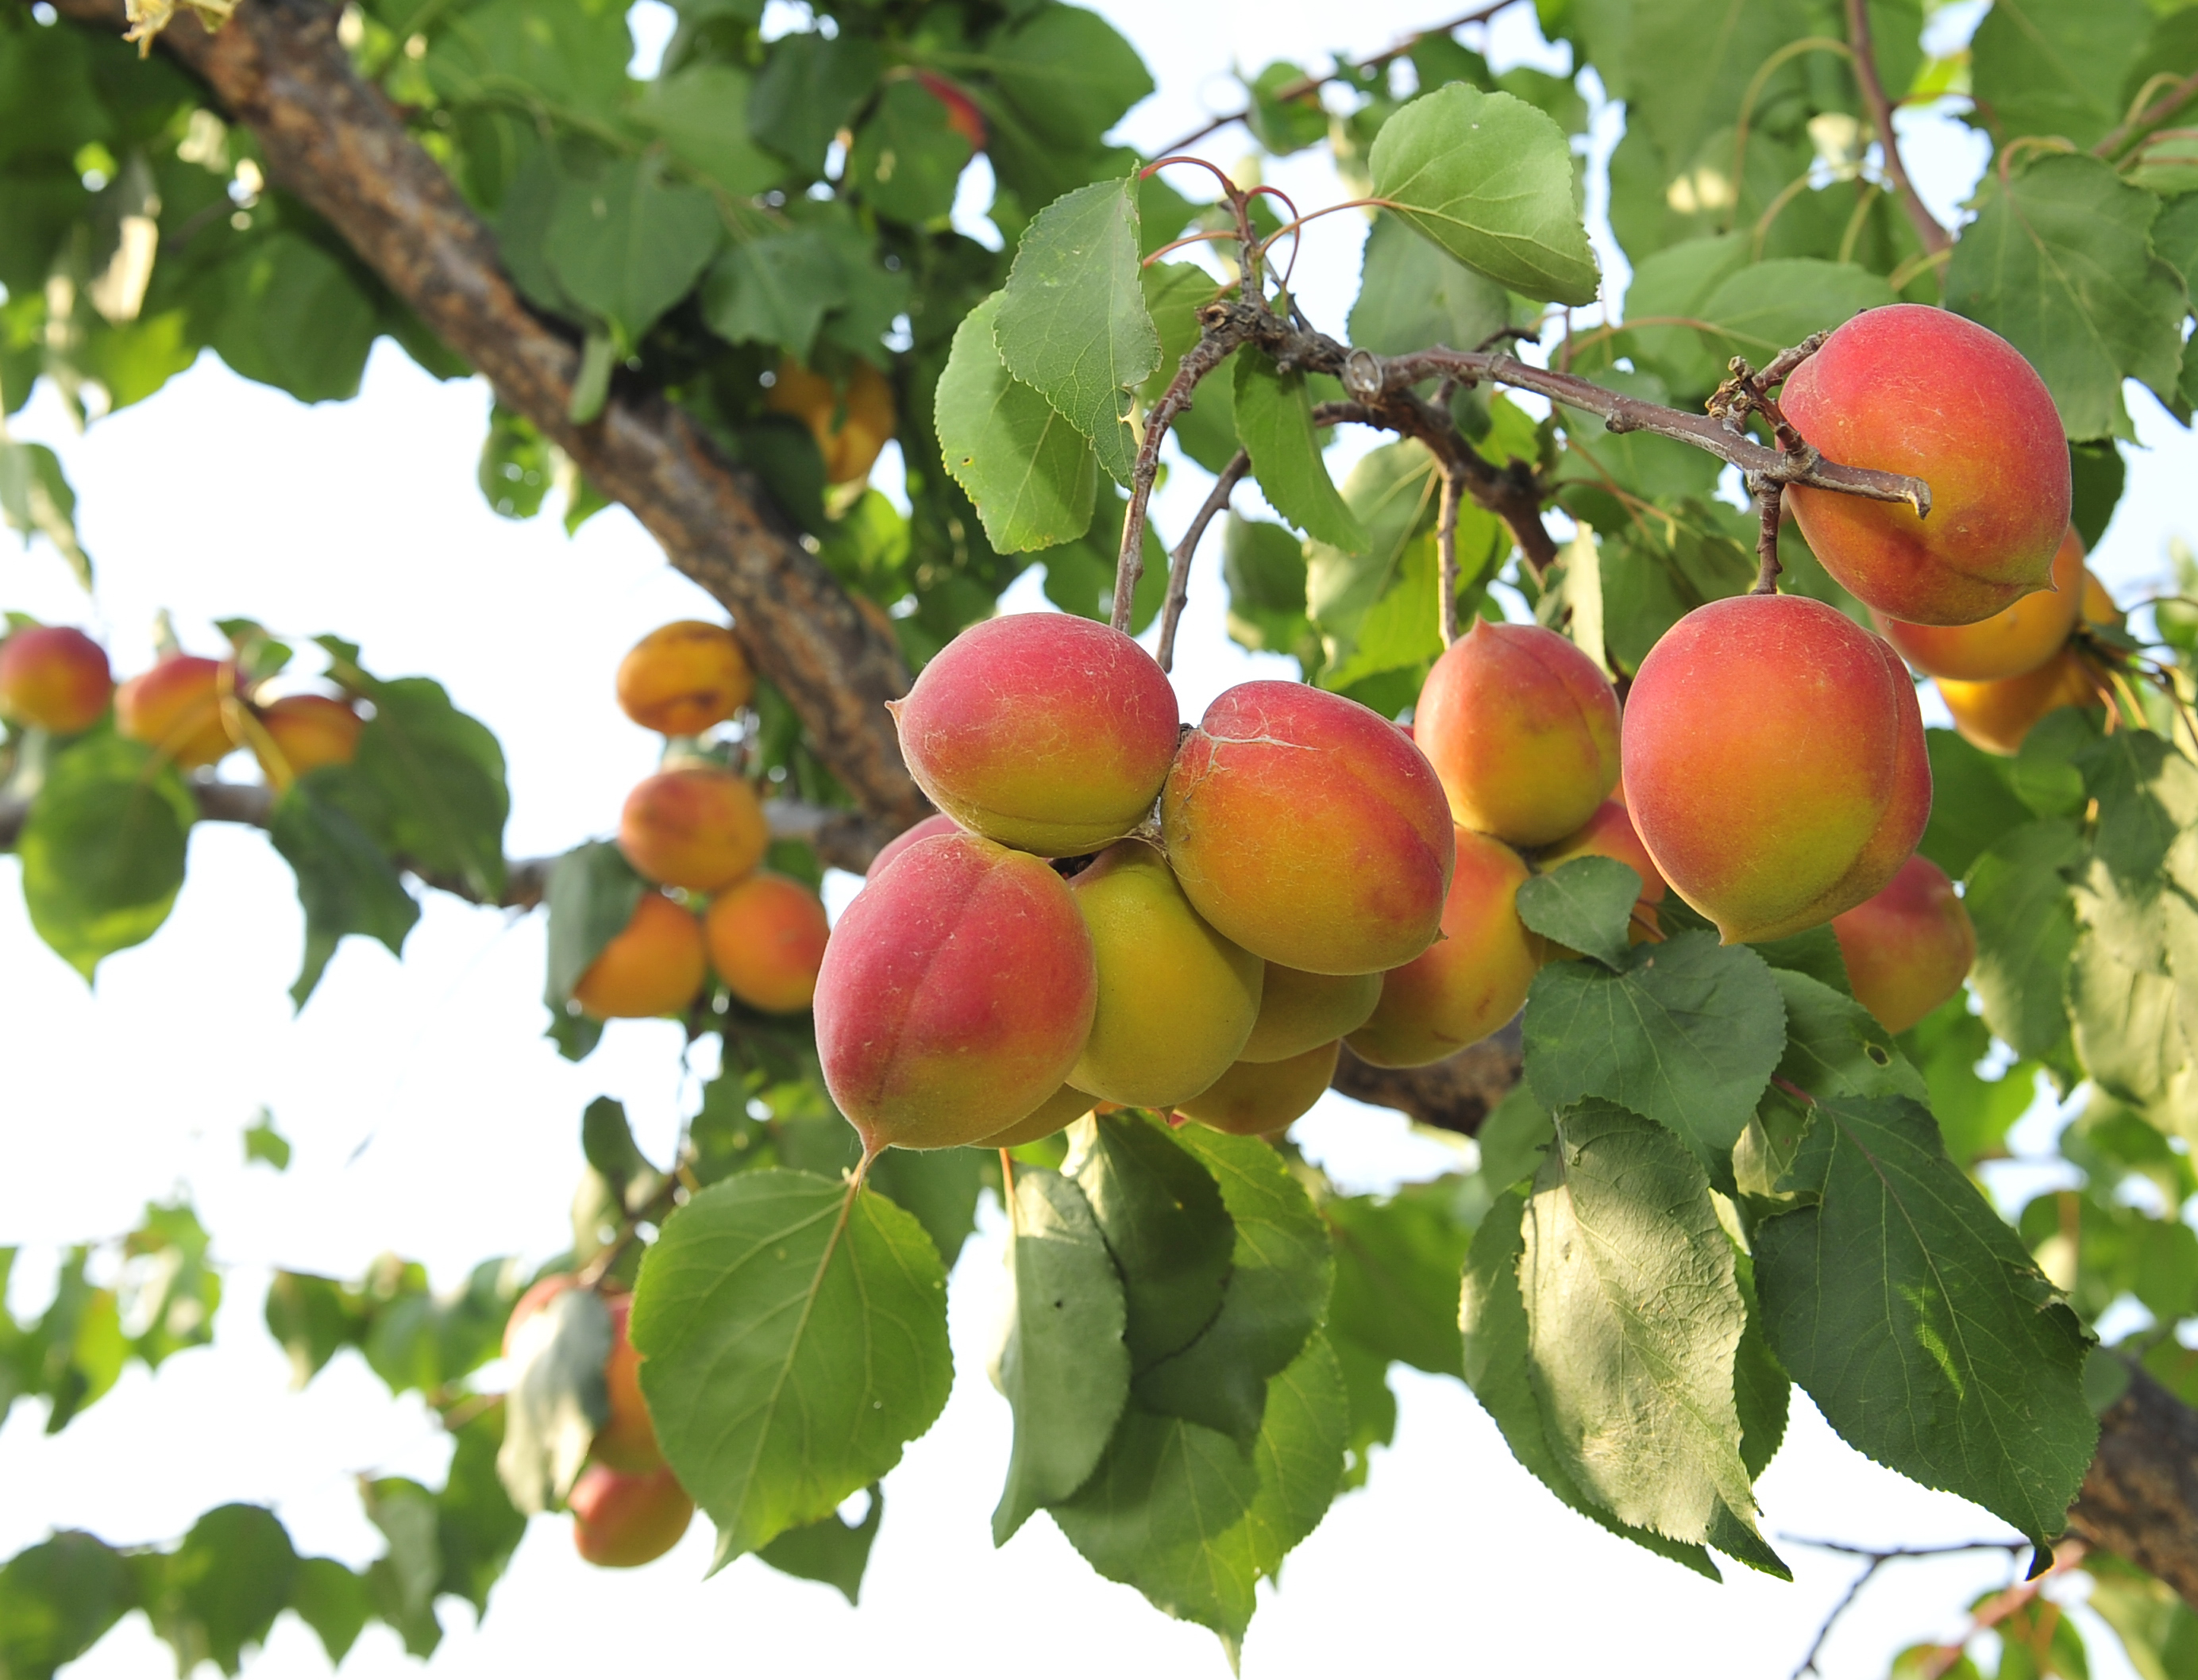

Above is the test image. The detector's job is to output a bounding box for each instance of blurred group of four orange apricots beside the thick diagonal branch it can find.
[573,620,829,1020]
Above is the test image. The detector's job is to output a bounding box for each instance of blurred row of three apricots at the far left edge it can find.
[0,625,364,788]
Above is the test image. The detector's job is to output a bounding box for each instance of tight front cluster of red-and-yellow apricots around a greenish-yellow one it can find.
[816,614,1457,1152]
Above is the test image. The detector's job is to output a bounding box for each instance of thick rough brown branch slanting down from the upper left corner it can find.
[44,0,925,825]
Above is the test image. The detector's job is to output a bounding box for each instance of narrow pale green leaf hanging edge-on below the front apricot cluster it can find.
[991,1166,1130,1546]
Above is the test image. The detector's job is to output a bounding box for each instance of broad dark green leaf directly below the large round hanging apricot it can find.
[1525,932,1785,1172]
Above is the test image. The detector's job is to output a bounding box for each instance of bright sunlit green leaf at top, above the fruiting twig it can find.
[1367,81,1600,303]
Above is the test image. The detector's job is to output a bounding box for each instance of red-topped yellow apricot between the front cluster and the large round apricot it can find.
[1411,618,1618,846]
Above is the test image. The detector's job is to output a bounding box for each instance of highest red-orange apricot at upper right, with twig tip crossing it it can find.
[1778,303,2069,625]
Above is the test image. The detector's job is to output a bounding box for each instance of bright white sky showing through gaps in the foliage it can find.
[0,0,2193,1680]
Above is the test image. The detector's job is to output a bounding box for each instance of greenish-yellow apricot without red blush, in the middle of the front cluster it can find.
[1068,840,1266,1108]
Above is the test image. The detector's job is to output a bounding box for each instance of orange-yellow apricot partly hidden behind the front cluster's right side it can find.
[1348,829,1545,1066]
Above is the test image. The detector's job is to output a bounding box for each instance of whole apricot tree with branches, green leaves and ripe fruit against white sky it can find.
[0,0,2198,1675]
